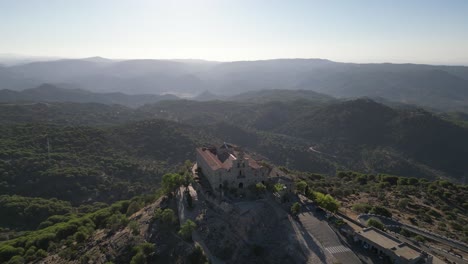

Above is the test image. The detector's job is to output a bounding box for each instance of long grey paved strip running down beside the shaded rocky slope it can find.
[299,205,362,264]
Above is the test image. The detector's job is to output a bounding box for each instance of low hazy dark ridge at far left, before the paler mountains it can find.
[0,84,179,107]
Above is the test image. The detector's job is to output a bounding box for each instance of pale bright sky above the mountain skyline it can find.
[0,0,468,64]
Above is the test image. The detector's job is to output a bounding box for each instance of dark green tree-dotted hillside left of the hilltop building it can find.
[0,120,207,204]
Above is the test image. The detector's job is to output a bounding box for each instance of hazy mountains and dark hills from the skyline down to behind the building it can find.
[0,57,468,184]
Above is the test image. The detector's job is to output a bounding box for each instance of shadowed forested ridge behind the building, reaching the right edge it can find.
[140,99,468,183]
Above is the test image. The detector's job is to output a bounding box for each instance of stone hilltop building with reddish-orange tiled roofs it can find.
[196,143,269,190]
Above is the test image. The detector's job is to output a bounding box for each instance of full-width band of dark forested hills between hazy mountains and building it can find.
[0,99,468,184]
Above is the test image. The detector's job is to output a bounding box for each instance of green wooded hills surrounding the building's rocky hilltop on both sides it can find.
[0,94,468,263]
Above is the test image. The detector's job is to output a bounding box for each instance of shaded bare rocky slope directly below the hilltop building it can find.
[198,201,307,263]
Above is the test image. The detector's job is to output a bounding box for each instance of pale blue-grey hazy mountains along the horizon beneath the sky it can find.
[0,57,468,111]
